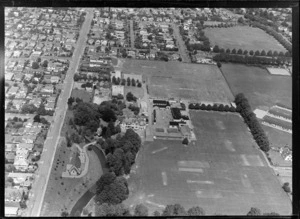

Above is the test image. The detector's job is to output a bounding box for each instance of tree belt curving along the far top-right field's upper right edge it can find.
[244,14,292,53]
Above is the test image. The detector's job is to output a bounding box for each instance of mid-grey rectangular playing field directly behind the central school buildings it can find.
[122,59,233,102]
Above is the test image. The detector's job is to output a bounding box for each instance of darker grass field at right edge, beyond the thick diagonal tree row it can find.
[221,63,292,110]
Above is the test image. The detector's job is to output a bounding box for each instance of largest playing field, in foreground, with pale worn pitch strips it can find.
[125,111,291,215]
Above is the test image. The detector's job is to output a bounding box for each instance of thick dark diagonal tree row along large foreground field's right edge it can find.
[235,93,270,152]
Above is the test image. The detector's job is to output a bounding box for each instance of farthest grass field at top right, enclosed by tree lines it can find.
[205,26,286,52]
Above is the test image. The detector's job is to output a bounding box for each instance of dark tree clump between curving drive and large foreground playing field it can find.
[98,129,141,176]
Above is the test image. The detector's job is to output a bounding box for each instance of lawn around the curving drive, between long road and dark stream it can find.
[41,141,102,216]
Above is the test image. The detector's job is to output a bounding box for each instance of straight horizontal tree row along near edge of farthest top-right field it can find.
[213,53,291,65]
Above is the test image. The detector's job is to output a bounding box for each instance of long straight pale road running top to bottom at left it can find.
[28,9,93,216]
